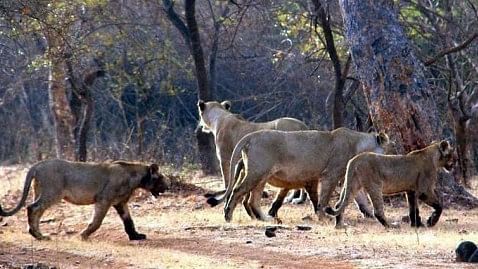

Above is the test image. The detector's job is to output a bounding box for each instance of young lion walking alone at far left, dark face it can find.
[0,159,167,240]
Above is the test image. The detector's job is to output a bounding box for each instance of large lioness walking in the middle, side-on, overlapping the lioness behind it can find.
[224,128,389,221]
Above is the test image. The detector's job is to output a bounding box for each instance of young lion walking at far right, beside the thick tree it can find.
[326,140,454,227]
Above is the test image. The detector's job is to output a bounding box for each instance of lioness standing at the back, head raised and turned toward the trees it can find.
[198,100,308,202]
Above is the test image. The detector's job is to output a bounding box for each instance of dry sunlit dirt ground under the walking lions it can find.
[0,163,478,268]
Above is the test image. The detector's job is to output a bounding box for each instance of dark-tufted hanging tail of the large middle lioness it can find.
[207,135,249,207]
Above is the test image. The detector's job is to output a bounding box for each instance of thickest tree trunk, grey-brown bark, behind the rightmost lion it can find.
[340,0,478,206]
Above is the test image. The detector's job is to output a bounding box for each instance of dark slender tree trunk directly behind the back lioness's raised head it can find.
[184,0,218,174]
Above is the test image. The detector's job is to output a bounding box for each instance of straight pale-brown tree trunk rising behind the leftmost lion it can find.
[46,32,75,160]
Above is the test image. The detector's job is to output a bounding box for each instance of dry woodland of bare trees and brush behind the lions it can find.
[0,0,478,199]
